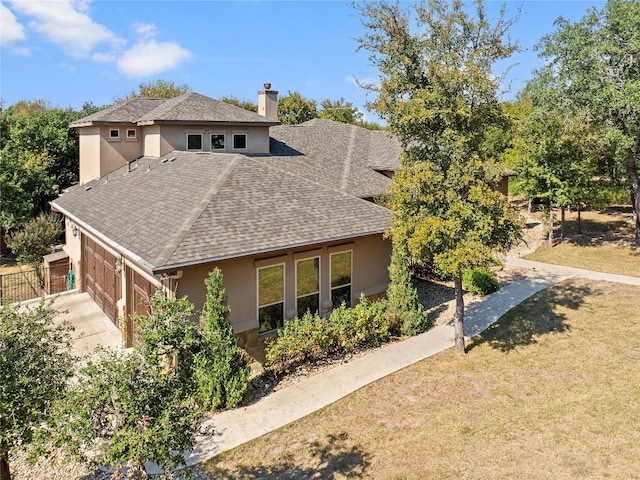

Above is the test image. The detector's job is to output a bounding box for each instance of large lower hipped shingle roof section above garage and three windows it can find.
[52,152,390,272]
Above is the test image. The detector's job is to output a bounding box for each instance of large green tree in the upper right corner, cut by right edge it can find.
[538,0,640,245]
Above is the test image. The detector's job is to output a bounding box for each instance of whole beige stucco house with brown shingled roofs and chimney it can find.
[52,84,400,358]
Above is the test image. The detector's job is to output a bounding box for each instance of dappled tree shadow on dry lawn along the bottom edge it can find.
[206,433,371,480]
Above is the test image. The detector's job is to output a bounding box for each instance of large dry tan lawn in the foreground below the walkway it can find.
[206,280,640,479]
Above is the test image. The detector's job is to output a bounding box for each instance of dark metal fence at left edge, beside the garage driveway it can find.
[0,265,76,305]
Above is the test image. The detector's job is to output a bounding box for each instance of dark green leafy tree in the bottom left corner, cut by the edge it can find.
[0,301,75,480]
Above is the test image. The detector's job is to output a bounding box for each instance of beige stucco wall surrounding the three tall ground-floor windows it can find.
[176,235,391,360]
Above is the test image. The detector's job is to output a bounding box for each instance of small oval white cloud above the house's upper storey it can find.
[118,40,192,77]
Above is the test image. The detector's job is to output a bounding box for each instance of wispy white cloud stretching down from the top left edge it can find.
[11,0,123,57]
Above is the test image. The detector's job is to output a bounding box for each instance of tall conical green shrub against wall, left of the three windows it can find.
[196,268,250,410]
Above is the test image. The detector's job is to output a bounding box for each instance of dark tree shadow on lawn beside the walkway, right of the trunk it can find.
[467,281,593,352]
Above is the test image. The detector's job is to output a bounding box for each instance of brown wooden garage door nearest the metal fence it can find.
[82,237,122,326]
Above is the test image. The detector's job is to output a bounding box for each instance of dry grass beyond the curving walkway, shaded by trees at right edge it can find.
[524,209,640,276]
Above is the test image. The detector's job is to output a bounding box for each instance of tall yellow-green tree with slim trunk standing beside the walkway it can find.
[355,0,520,354]
